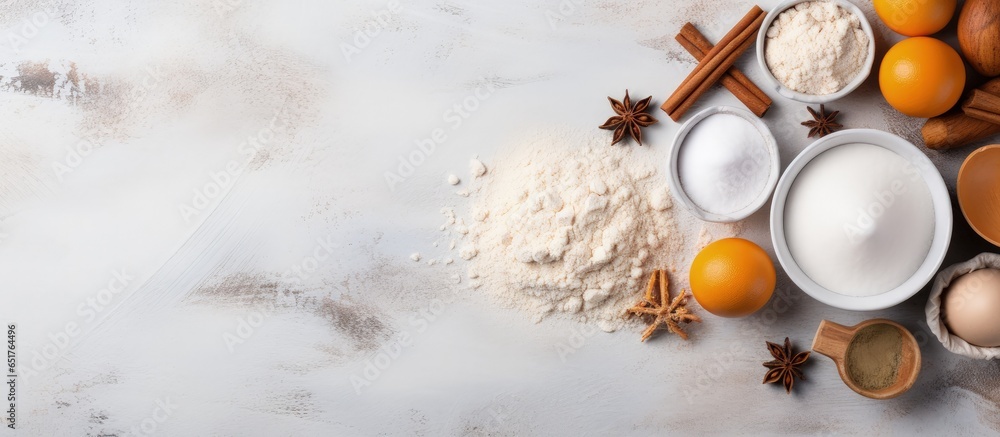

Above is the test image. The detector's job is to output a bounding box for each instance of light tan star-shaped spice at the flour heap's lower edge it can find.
[625,270,701,341]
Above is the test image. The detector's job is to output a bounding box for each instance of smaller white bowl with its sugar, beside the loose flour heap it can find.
[668,106,781,223]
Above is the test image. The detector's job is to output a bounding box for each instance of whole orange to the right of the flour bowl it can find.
[878,36,965,118]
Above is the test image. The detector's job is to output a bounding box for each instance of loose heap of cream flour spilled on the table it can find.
[454,133,684,332]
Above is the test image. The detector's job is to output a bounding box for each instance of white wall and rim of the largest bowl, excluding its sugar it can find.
[771,129,952,311]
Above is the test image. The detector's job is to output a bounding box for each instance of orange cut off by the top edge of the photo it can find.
[873,0,957,36]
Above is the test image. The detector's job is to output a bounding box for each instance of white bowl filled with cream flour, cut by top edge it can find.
[757,0,875,103]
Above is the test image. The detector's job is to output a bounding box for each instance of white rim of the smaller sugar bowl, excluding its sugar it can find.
[667,106,781,223]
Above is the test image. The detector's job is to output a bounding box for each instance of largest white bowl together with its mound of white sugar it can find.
[771,129,952,311]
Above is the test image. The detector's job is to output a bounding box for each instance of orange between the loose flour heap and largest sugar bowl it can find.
[690,238,776,317]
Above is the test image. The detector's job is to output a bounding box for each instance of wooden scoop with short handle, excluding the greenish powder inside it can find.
[813,319,920,399]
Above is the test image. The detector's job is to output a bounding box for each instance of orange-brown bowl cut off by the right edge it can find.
[957,144,1000,246]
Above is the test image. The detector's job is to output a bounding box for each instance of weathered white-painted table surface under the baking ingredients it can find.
[0,0,1000,436]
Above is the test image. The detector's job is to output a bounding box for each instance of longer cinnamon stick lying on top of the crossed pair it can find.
[660,5,764,121]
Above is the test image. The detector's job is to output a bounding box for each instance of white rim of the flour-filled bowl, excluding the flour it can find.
[757,0,875,103]
